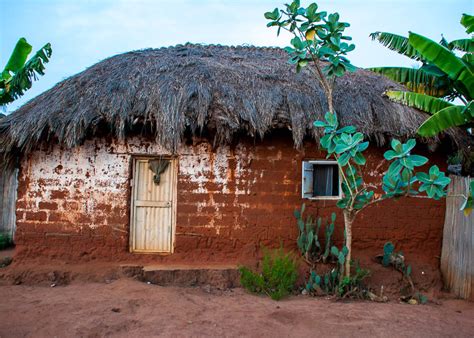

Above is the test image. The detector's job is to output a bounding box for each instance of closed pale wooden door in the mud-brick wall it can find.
[130,158,176,253]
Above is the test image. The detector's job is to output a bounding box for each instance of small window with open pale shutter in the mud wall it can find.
[302,161,341,199]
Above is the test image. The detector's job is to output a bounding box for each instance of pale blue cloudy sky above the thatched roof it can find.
[0,0,474,113]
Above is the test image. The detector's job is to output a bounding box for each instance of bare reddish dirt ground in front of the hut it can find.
[0,279,474,337]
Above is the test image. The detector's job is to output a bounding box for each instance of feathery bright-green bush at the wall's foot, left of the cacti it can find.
[239,248,298,300]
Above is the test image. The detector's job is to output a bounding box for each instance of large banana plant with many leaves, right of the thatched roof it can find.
[370,14,474,137]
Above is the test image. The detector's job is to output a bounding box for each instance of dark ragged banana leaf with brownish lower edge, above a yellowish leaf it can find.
[369,67,452,97]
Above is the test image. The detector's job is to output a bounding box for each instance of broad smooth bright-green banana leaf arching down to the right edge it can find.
[408,33,474,101]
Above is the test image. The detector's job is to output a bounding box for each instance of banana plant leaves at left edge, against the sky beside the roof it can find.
[0,38,52,106]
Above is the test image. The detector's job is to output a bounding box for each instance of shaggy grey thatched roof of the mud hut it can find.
[0,45,462,153]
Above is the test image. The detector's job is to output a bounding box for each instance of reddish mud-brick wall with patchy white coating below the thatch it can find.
[16,135,445,263]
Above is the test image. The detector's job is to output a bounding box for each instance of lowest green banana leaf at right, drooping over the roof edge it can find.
[418,106,472,137]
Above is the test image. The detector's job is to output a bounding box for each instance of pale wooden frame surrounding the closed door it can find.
[129,155,178,256]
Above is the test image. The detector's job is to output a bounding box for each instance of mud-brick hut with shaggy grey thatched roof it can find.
[0,45,457,263]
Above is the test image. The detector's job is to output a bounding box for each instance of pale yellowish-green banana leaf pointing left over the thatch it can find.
[386,91,454,115]
